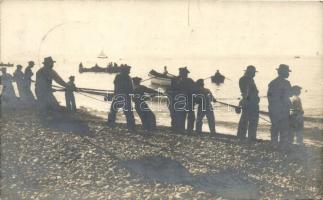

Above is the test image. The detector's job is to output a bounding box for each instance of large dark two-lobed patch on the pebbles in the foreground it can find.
[121,156,260,199]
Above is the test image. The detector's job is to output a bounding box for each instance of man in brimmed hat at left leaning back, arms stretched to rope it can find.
[35,57,67,116]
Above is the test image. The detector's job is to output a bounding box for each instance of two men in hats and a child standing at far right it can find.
[237,64,304,144]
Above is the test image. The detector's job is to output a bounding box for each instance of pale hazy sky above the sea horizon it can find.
[0,0,323,62]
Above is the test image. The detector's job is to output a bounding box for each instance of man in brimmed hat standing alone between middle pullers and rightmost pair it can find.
[237,65,260,140]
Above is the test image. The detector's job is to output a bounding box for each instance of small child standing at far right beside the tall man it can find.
[290,85,304,144]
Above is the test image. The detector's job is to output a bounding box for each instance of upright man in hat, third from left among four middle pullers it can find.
[175,67,196,133]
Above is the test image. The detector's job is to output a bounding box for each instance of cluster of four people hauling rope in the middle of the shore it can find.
[108,66,216,133]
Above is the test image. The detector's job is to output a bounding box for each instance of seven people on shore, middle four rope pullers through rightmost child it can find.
[108,64,304,144]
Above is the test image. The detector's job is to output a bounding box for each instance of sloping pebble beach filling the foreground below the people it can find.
[1,106,323,199]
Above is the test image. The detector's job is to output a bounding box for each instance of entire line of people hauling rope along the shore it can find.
[1,57,304,143]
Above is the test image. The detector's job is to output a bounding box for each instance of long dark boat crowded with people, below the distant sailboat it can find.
[79,62,128,74]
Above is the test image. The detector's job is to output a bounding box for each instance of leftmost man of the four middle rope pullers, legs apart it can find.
[108,65,135,131]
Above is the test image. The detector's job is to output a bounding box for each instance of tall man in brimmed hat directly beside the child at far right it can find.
[267,64,292,143]
